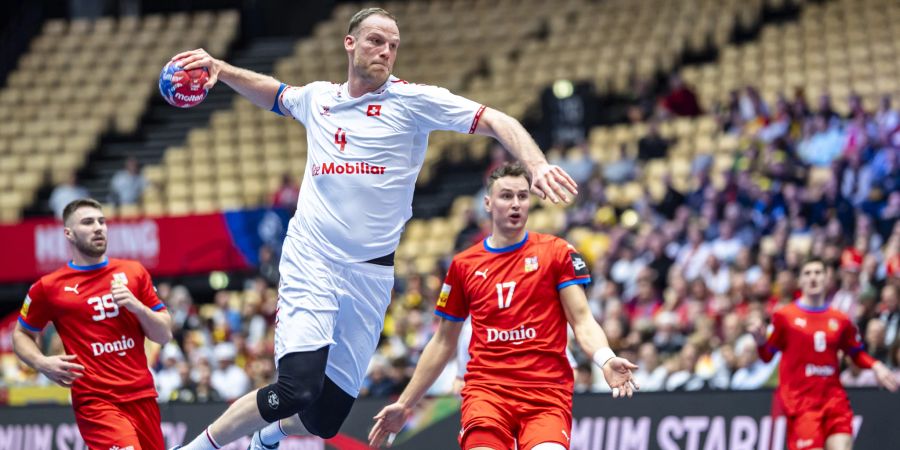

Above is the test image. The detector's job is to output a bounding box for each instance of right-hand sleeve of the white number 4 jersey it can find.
[398,84,484,134]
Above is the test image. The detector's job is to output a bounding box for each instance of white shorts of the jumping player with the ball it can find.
[275,236,394,398]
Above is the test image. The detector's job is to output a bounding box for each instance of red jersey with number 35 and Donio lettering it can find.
[19,259,165,402]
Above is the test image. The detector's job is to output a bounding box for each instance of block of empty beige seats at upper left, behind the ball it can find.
[0,11,238,222]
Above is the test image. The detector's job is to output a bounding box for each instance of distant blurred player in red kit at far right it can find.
[750,259,897,450]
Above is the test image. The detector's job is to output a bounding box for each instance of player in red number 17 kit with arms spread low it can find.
[369,164,638,450]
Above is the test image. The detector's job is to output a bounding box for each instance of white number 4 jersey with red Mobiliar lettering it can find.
[281,76,484,262]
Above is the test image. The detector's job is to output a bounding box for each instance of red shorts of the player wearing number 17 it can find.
[459,384,572,450]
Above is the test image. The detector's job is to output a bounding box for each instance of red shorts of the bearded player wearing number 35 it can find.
[74,398,166,450]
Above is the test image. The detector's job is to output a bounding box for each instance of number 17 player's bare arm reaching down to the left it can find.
[369,319,463,447]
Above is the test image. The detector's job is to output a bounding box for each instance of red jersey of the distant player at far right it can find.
[759,302,875,415]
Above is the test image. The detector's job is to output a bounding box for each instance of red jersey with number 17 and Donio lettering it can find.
[435,233,591,390]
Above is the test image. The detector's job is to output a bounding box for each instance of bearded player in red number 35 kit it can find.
[13,199,172,450]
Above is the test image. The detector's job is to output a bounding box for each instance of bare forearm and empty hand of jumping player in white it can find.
[475,108,578,203]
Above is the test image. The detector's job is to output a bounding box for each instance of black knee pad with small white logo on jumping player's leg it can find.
[256,347,328,423]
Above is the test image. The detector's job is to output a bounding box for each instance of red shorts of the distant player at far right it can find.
[787,397,853,450]
